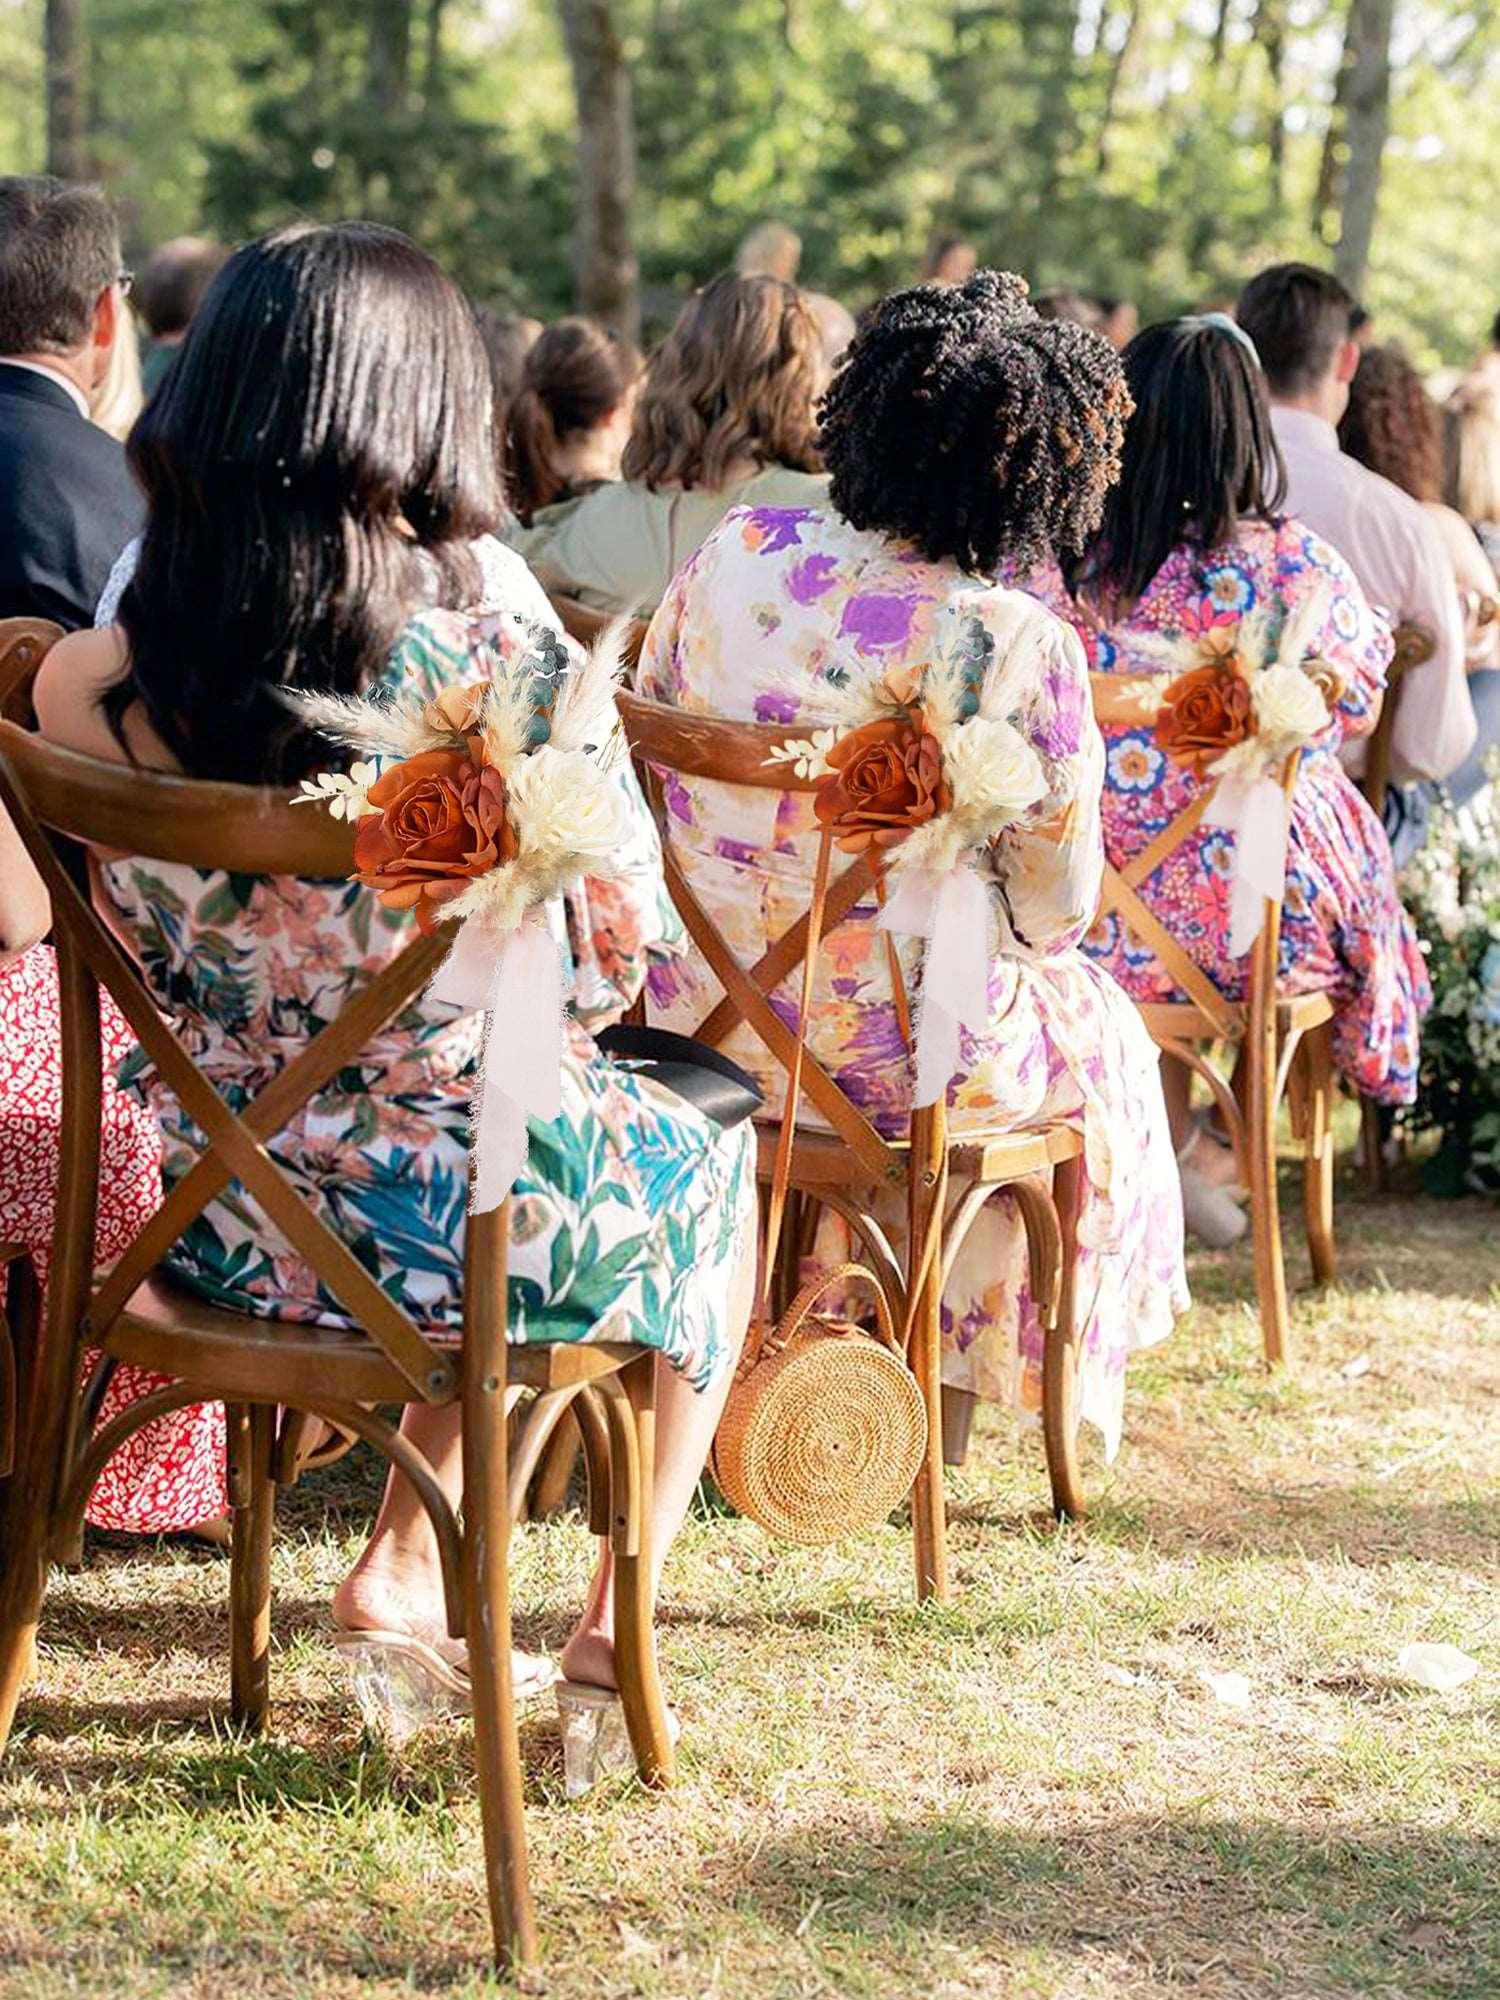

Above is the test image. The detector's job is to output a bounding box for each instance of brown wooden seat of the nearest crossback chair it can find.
[102,1272,640,1404]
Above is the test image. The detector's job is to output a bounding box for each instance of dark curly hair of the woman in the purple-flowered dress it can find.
[820,270,1130,576]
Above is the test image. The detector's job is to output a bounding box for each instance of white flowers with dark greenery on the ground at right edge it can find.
[1402,758,1500,1194]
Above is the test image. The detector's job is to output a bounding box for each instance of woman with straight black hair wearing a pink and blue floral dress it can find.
[1026,314,1428,1240]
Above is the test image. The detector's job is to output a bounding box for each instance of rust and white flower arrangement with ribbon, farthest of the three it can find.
[1136,590,1342,956]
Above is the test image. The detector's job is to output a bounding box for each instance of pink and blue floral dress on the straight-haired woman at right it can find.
[1026,520,1432,1104]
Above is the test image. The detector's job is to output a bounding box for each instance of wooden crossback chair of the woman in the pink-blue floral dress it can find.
[1090,674,1338,1366]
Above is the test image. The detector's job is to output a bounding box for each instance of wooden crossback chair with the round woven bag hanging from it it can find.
[620,696,1084,1600]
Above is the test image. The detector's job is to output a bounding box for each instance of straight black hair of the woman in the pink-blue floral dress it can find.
[1066,318,1286,606]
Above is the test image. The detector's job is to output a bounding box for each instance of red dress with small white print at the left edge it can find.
[0,944,228,1534]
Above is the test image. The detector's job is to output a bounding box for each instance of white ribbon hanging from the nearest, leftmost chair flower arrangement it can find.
[428,918,562,1216]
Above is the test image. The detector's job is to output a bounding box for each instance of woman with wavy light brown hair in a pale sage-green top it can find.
[524,274,828,618]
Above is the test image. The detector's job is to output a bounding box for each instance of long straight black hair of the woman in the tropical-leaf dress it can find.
[104,222,502,784]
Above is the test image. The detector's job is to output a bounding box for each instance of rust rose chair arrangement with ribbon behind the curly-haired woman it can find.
[774,638,1062,1106]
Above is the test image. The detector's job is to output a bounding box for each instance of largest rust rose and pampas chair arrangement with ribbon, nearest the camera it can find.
[288,628,626,1212]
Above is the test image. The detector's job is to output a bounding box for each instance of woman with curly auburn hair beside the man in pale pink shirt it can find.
[1338,346,1500,806]
